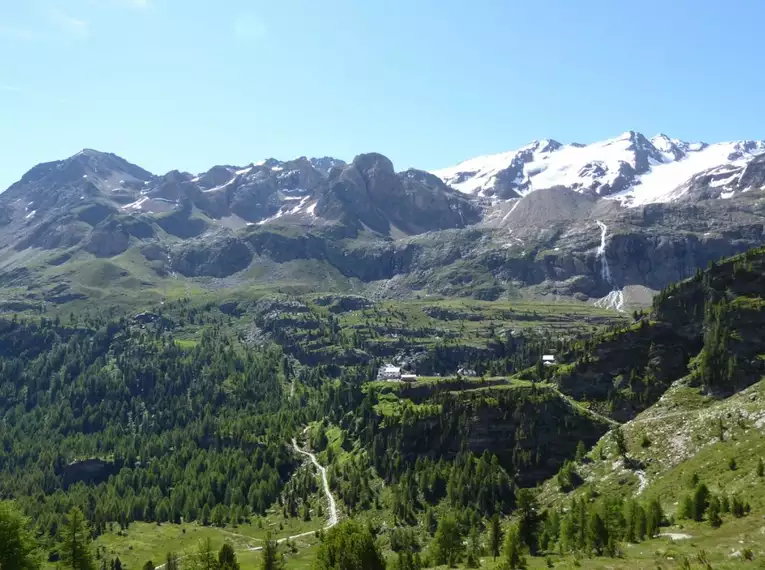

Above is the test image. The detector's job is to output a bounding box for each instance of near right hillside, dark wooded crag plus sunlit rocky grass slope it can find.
[539,248,765,568]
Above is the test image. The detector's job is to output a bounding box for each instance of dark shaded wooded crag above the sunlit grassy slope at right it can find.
[555,244,765,421]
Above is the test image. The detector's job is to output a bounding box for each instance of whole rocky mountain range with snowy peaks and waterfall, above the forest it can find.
[0,131,765,311]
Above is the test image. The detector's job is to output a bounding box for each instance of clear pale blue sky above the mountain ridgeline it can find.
[0,0,765,188]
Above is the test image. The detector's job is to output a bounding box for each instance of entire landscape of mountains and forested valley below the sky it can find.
[0,133,765,570]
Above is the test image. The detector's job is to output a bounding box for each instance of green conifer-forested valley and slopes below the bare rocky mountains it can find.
[0,244,765,570]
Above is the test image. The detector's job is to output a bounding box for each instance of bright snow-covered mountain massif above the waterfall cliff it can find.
[433,131,765,206]
